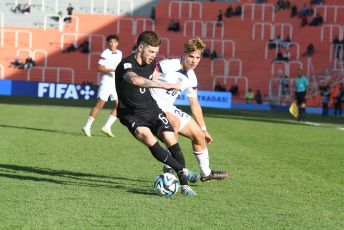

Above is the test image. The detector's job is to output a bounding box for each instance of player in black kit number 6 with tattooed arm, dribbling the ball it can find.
[115,31,200,196]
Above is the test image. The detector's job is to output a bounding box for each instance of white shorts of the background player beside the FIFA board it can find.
[97,75,118,101]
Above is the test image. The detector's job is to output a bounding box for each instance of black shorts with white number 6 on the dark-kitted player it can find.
[119,108,174,138]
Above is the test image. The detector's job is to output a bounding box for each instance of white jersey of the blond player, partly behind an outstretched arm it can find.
[150,59,198,107]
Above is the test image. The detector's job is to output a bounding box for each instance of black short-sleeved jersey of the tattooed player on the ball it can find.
[115,54,158,117]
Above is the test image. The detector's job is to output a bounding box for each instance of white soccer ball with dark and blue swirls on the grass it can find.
[154,173,179,197]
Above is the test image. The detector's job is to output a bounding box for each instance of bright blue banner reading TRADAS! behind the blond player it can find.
[174,90,232,109]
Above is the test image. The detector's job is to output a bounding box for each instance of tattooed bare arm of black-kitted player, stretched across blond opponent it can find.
[123,72,181,90]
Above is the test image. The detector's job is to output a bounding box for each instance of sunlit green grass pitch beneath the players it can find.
[0,96,344,230]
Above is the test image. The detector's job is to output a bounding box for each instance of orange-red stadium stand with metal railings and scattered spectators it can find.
[0,0,344,104]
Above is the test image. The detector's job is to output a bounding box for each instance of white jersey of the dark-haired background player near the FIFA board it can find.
[98,49,122,77]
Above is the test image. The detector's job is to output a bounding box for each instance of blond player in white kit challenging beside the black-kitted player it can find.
[150,37,228,182]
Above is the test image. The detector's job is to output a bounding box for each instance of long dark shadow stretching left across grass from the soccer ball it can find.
[0,164,154,195]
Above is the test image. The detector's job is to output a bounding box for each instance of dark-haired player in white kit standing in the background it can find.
[82,35,122,137]
